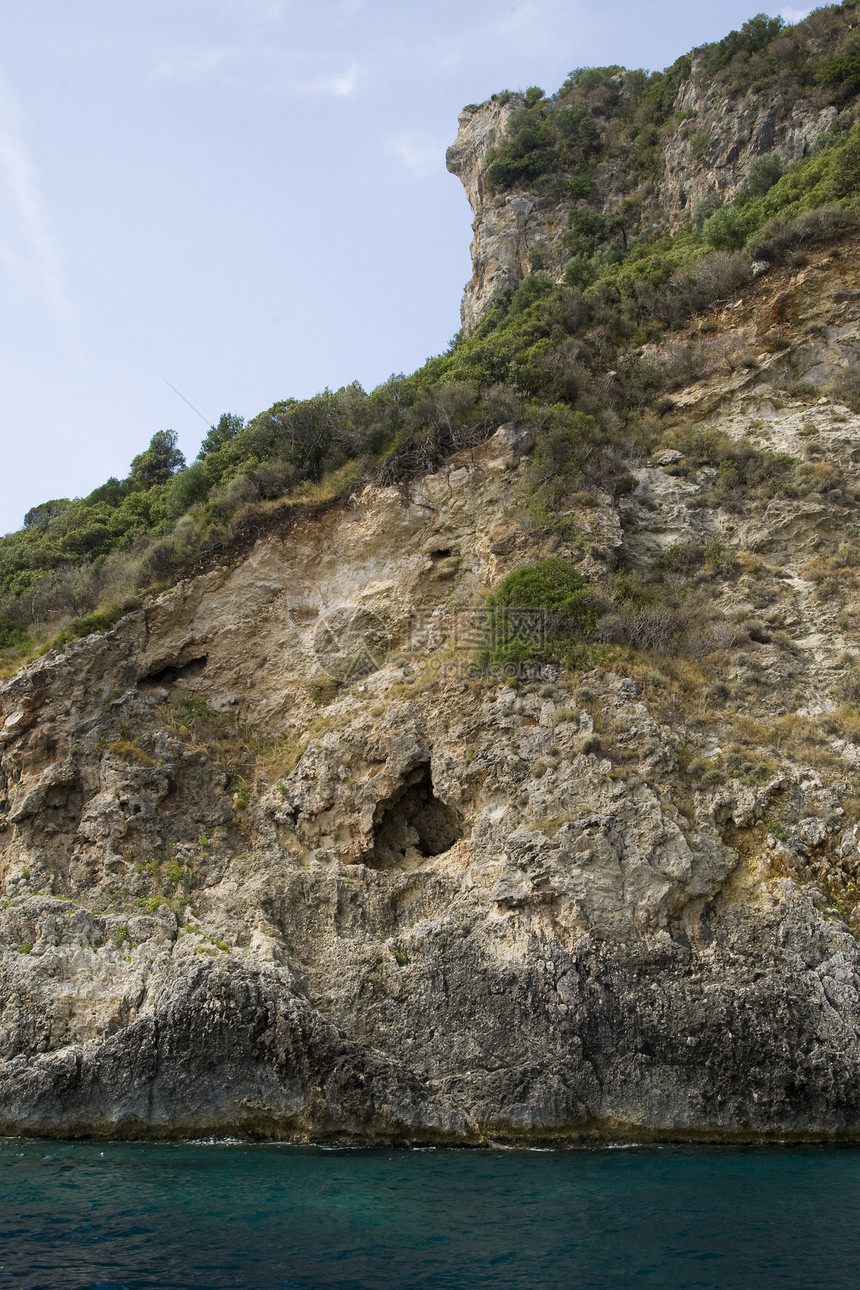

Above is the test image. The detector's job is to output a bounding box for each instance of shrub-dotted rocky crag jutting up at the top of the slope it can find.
[447,6,860,334]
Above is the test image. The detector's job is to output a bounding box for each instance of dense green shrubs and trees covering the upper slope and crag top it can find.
[0,0,860,660]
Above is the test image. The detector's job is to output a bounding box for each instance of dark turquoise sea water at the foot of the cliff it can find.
[0,1139,860,1290]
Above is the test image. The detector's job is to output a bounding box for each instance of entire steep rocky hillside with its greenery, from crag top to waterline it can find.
[8,3,860,1143]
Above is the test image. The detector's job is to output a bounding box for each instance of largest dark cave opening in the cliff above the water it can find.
[364,762,462,869]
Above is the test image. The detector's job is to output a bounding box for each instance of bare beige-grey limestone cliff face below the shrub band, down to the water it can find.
[0,246,860,1142]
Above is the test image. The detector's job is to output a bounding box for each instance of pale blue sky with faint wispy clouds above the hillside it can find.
[0,0,808,533]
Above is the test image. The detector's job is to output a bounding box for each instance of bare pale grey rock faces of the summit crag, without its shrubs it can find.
[447,75,855,334]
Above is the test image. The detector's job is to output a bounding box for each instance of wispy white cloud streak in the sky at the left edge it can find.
[0,83,72,328]
